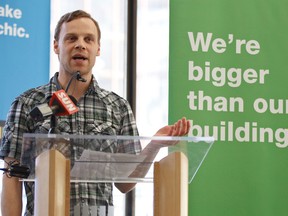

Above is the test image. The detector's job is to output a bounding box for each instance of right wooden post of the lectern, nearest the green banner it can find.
[154,152,188,216]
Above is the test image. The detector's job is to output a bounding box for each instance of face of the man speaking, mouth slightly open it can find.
[54,18,100,75]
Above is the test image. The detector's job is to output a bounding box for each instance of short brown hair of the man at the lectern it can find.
[54,10,101,44]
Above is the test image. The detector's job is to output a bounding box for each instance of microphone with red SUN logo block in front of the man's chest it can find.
[29,89,79,121]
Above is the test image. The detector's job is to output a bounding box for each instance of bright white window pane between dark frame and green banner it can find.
[135,0,169,216]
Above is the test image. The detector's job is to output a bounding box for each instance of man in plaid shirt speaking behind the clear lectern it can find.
[0,10,190,216]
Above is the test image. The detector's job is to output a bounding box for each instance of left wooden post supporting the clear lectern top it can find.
[34,150,70,216]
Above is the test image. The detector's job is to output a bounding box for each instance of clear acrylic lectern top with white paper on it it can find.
[21,134,213,183]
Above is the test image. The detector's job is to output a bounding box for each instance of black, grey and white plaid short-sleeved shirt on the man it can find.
[0,73,141,215]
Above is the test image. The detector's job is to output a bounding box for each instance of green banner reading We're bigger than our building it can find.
[169,0,288,216]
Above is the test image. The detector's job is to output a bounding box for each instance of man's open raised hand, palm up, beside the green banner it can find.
[155,117,190,136]
